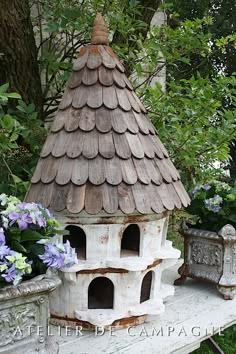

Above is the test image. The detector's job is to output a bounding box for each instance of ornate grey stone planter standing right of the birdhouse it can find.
[175,225,236,300]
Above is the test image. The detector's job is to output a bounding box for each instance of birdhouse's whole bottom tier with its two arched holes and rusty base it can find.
[50,259,175,329]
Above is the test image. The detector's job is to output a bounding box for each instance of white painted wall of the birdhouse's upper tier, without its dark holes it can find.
[58,218,171,262]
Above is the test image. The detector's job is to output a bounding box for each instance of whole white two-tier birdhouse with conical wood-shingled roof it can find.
[26,14,189,328]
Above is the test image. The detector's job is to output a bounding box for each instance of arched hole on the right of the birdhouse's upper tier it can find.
[121,224,140,257]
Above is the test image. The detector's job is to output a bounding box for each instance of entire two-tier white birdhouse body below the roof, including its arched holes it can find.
[50,212,180,329]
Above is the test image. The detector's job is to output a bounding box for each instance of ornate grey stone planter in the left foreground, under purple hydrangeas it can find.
[0,275,60,354]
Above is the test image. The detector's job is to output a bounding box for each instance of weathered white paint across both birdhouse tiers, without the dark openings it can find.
[50,216,180,326]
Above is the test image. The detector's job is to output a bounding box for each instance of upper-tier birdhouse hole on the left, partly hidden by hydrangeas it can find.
[63,225,86,259]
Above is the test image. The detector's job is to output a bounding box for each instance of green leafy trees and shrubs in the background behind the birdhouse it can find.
[0,0,236,353]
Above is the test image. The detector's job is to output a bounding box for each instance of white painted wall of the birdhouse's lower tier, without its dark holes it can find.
[50,264,174,326]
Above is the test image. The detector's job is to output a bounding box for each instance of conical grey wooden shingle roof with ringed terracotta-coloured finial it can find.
[26,15,190,215]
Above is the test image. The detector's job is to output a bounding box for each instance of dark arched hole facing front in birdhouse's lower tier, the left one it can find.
[88,277,114,309]
